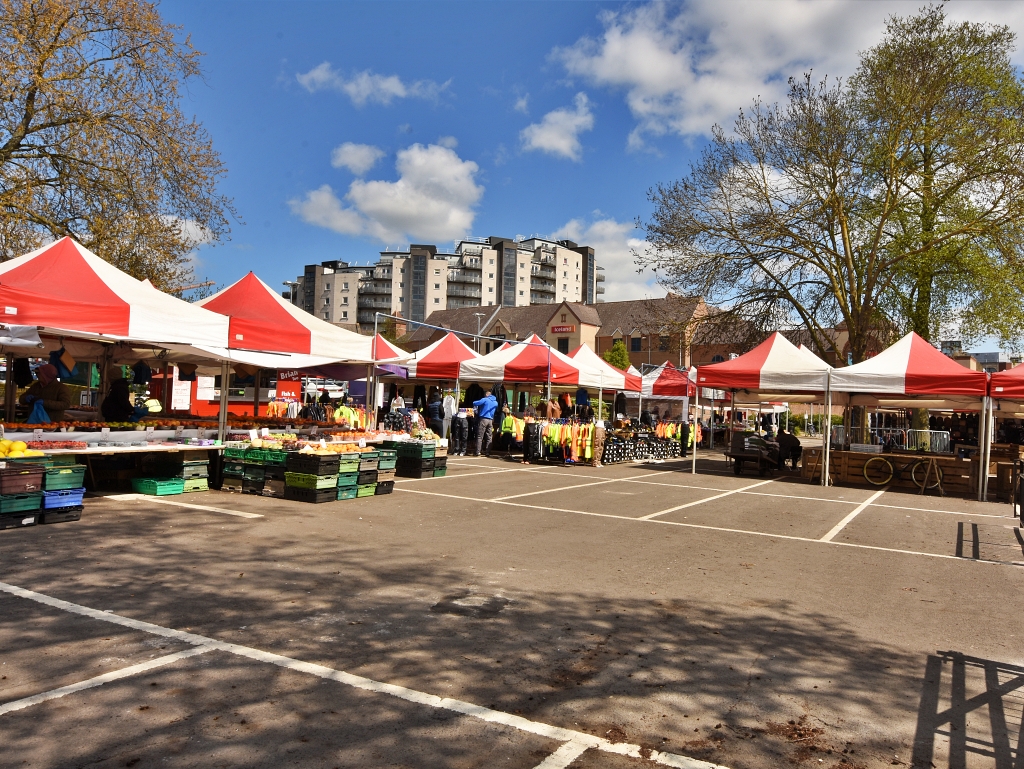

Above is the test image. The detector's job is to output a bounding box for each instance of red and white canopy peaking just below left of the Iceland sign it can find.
[459,334,600,387]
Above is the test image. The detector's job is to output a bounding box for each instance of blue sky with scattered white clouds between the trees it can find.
[160,0,1024,321]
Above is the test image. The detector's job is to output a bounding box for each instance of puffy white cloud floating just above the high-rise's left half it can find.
[289,144,483,245]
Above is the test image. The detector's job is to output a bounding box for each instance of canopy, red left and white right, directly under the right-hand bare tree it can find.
[697,331,830,393]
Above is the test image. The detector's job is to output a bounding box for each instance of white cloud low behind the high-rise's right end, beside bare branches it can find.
[551,217,666,302]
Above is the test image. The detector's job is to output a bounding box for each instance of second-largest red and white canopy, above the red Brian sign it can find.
[199,272,373,367]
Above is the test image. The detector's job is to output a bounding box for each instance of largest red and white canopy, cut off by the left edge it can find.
[0,238,228,347]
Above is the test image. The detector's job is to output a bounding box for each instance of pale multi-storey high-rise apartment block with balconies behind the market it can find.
[285,237,604,331]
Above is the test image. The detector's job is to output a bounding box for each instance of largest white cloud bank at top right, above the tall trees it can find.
[552,0,1024,148]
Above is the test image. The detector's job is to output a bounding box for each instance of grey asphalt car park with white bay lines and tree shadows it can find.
[0,458,1024,769]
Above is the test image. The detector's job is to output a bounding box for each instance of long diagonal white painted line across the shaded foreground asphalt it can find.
[0,582,725,769]
